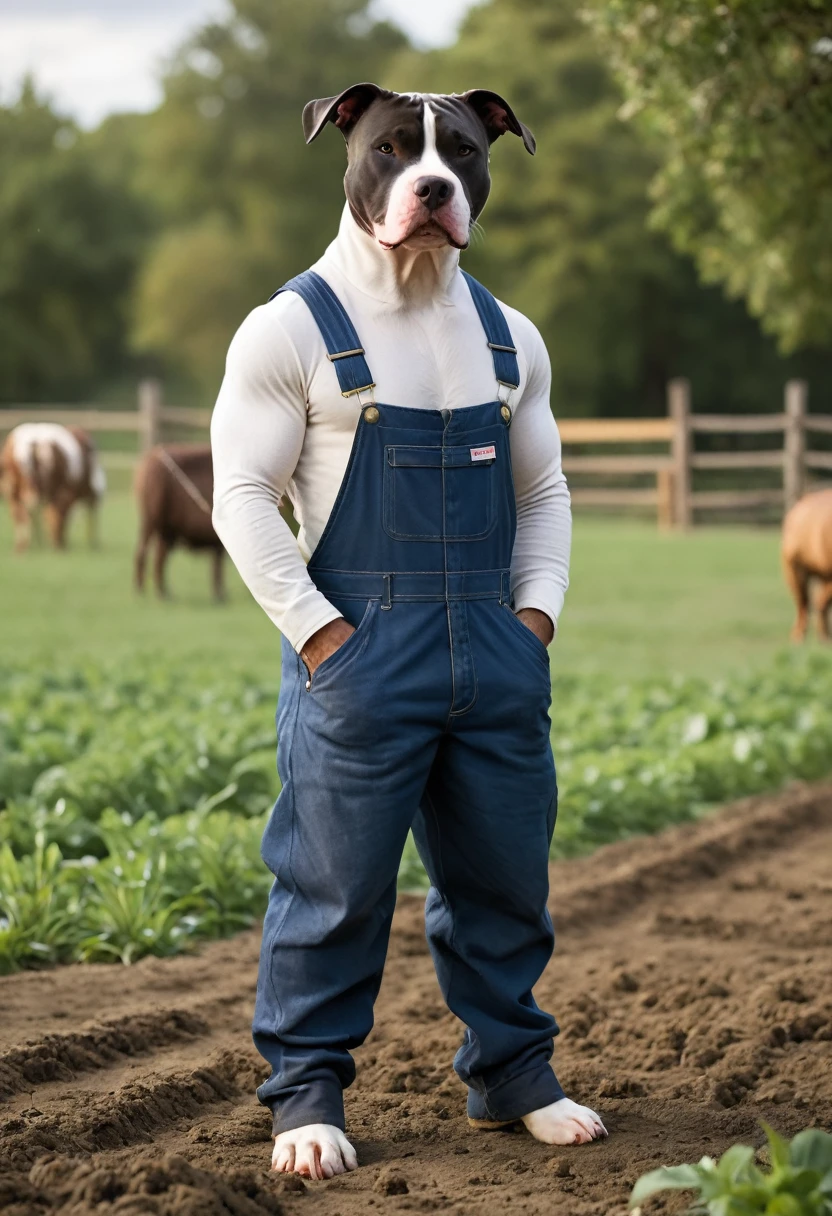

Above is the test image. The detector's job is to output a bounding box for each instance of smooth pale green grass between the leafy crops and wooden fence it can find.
[0,494,792,679]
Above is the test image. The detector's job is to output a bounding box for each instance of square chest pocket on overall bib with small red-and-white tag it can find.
[383,444,496,541]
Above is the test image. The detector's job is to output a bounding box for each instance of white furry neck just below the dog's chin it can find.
[321,204,460,309]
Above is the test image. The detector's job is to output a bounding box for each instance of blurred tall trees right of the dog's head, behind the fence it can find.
[390,0,830,415]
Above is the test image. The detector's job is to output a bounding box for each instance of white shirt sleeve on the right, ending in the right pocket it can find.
[510,314,572,630]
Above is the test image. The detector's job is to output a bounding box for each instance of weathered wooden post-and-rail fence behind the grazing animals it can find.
[0,379,832,529]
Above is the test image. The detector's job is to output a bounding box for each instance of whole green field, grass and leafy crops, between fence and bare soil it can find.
[0,499,832,972]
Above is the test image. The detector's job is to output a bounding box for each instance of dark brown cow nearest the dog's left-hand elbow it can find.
[135,444,225,601]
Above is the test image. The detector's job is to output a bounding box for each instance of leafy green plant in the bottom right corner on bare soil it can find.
[630,1124,832,1216]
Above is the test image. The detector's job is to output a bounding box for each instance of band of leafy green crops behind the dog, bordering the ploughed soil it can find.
[0,651,832,975]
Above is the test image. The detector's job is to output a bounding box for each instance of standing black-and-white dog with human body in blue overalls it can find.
[212,84,606,1178]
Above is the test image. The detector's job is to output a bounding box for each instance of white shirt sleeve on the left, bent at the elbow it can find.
[210,297,341,651]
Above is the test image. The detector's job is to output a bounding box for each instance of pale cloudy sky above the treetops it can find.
[0,0,472,126]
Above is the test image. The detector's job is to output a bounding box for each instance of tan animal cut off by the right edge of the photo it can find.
[782,490,832,642]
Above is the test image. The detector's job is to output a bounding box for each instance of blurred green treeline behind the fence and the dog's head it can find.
[0,0,832,416]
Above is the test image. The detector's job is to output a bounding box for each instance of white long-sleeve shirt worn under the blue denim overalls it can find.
[212,209,572,651]
